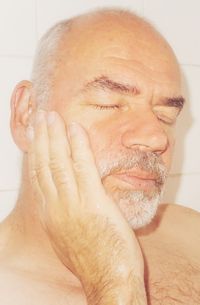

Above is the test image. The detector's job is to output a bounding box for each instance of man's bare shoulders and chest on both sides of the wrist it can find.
[0,204,200,305]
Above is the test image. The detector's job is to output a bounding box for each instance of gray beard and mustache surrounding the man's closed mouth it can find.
[99,150,167,230]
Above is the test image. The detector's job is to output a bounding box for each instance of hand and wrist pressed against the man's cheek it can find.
[28,111,145,305]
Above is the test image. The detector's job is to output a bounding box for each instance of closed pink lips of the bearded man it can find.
[113,172,158,190]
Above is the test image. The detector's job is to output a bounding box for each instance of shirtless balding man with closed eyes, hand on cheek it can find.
[0,10,200,305]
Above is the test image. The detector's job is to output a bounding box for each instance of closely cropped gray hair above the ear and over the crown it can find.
[31,8,155,105]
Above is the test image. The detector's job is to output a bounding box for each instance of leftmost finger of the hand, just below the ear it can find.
[29,110,57,202]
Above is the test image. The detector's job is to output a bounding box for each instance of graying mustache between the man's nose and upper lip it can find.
[100,150,168,185]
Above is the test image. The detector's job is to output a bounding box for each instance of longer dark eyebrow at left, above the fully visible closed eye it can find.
[83,75,139,95]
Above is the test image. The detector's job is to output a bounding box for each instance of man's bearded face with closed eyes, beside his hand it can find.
[46,15,182,229]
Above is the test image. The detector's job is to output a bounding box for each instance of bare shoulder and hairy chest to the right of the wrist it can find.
[139,205,200,305]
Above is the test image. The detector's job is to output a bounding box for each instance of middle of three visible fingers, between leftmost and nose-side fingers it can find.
[47,111,78,204]
